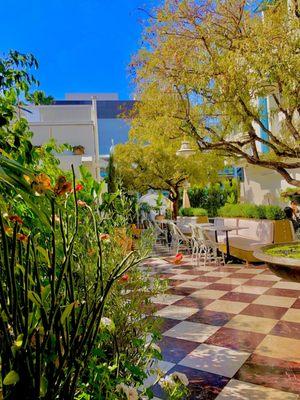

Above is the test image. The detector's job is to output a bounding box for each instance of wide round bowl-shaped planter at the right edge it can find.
[254,242,300,282]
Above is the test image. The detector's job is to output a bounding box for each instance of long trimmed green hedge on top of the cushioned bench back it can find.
[218,204,285,220]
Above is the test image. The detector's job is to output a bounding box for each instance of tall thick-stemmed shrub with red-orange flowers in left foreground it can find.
[0,161,155,400]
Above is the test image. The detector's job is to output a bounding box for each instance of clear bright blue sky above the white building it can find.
[0,0,158,99]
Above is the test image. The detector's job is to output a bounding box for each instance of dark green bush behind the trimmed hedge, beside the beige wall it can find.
[188,179,239,217]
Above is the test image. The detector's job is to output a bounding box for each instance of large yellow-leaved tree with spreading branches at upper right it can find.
[133,0,300,186]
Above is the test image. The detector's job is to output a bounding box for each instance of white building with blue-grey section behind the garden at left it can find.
[23,93,134,180]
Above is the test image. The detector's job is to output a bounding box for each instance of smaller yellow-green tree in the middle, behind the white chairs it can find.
[114,110,223,217]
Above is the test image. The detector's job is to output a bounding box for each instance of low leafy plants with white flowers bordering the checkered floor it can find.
[80,256,164,400]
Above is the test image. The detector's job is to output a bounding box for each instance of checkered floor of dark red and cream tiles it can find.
[142,252,300,400]
